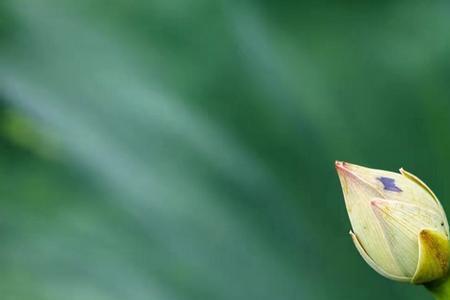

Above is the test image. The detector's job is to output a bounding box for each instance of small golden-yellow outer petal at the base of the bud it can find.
[412,229,450,284]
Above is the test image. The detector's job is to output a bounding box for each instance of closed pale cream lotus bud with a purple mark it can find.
[336,161,449,284]
